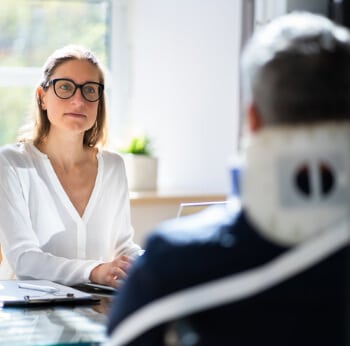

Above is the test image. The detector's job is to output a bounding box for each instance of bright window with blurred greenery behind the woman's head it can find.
[0,0,114,145]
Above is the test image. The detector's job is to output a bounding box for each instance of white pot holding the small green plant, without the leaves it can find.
[123,154,158,191]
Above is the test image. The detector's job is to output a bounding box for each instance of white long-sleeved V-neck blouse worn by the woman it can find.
[0,143,140,285]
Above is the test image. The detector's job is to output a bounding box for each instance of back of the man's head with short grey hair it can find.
[242,12,350,129]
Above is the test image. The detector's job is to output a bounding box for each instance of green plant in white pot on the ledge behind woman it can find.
[121,136,158,191]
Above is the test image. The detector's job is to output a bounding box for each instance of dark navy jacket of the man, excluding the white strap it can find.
[108,207,350,346]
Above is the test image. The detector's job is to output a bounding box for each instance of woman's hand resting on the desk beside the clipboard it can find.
[89,255,131,288]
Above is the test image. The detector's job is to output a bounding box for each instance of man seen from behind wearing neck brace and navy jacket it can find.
[108,13,350,346]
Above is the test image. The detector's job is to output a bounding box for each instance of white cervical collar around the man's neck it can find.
[241,123,350,246]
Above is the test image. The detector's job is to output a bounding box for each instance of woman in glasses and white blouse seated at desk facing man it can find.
[0,46,140,287]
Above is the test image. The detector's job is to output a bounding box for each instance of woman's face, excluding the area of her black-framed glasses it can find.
[40,60,100,136]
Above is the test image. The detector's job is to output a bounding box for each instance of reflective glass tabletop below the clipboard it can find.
[0,297,112,346]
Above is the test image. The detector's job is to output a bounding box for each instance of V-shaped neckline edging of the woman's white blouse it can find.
[30,143,103,222]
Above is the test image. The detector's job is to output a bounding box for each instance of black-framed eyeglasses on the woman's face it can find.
[43,78,104,102]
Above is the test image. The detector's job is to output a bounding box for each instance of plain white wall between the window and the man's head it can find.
[123,0,240,193]
